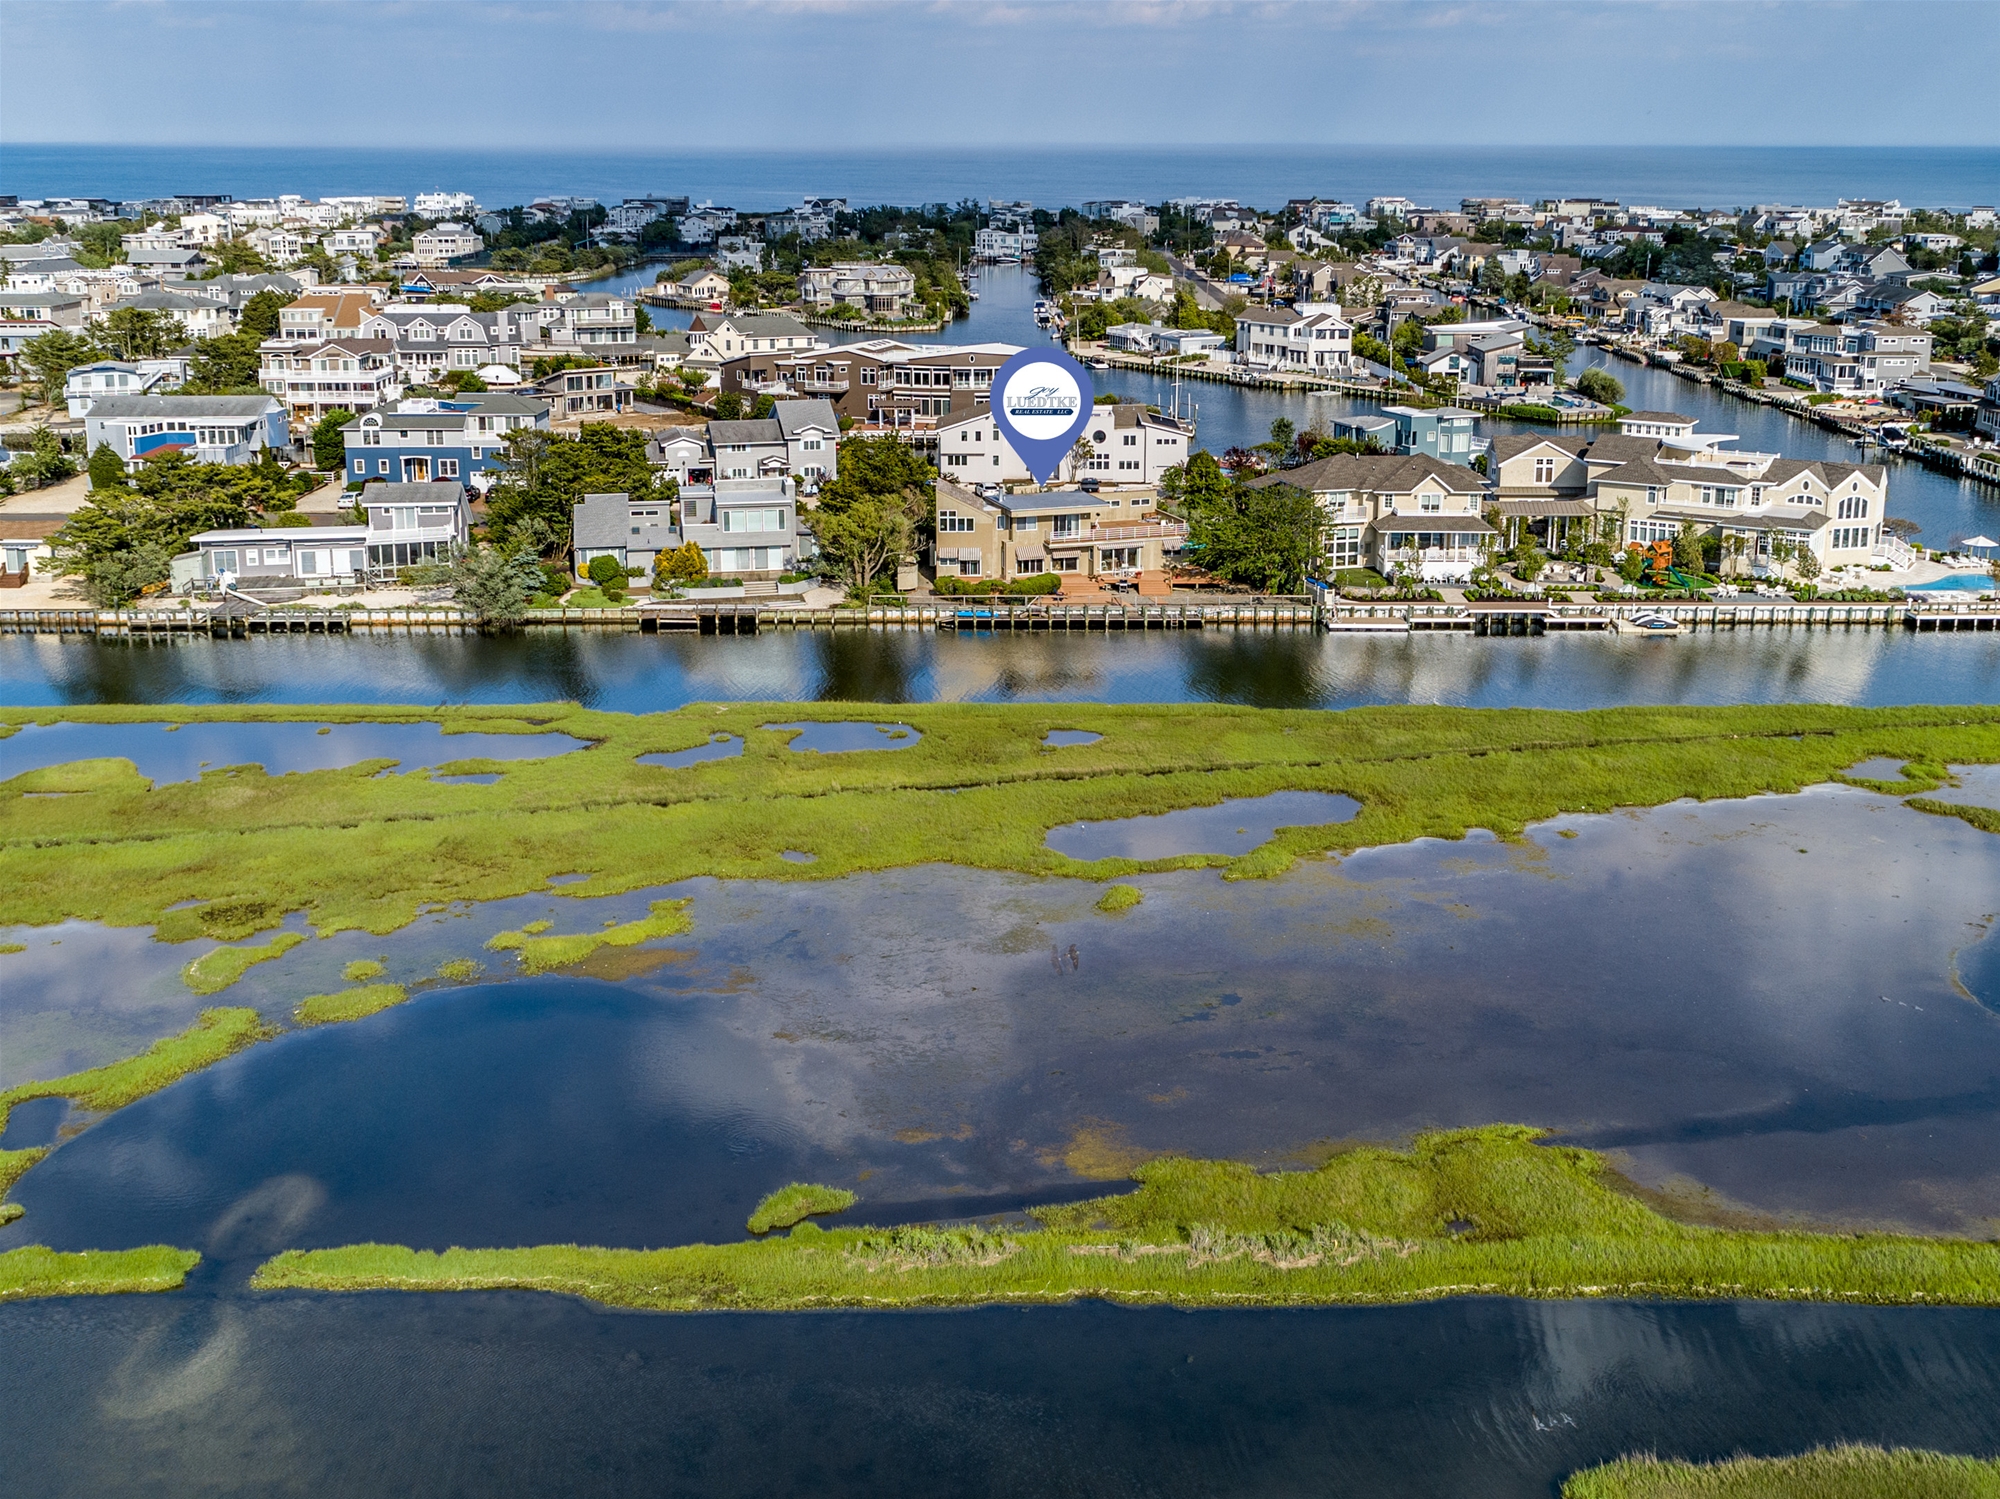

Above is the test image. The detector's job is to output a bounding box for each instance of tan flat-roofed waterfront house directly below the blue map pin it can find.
[932,478,1188,582]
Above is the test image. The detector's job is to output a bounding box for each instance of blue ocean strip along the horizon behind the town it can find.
[0,144,2000,212]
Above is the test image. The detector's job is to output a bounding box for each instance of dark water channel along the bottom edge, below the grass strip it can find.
[0,1289,2000,1499]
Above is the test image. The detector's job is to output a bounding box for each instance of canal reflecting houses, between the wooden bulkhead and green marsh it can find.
[0,628,2000,715]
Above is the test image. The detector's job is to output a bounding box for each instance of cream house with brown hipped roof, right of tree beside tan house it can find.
[1250,451,1494,582]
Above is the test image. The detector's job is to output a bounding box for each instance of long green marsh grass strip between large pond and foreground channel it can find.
[254,1125,2000,1311]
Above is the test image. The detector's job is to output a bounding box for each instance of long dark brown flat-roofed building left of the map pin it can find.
[720,338,1020,432]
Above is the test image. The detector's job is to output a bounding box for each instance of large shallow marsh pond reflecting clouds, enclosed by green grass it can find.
[15,787,2000,1247]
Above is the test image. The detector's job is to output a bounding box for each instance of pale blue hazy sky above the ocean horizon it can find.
[0,0,2000,150]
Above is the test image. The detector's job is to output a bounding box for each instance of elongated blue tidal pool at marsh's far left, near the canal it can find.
[0,724,586,783]
